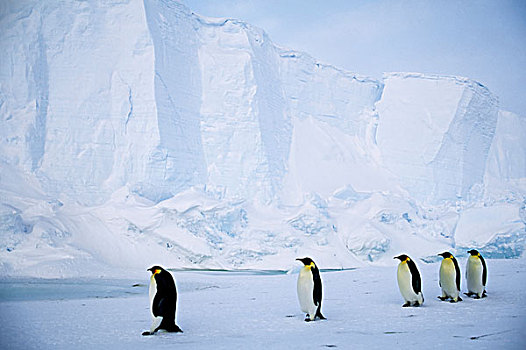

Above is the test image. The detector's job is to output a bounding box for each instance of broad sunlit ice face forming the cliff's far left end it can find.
[0,1,160,204]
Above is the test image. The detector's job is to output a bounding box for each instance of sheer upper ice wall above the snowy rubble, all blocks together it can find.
[2,1,520,208]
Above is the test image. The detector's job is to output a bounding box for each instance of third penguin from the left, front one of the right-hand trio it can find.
[393,254,424,307]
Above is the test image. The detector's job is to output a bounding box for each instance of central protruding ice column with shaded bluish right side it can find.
[197,19,291,201]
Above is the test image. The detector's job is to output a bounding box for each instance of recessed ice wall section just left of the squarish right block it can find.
[280,49,389,203]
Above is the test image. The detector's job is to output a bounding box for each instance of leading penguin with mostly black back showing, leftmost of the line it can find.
[142,266,183,335]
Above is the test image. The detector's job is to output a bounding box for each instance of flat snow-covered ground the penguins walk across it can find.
[0,258,526,349]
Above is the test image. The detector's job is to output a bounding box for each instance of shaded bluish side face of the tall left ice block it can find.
[142,1,206,202]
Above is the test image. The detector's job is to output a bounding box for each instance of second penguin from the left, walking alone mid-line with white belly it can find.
[296,258,326,322]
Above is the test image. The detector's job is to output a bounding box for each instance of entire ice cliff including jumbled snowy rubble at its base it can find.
[0,0,526,276]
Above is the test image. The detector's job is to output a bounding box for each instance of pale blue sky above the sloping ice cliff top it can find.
[183,0,526,117]
